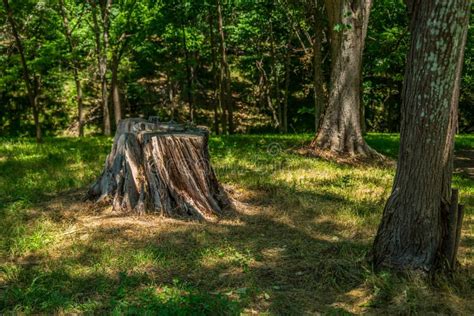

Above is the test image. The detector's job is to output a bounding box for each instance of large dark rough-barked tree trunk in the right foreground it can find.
[373,0,470,271]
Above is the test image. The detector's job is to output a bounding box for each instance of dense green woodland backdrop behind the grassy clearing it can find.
[0,0,474,136]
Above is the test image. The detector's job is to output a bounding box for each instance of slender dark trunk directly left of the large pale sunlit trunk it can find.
[313,0,327,133]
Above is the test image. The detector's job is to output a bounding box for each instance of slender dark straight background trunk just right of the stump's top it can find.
[216,0,234,134]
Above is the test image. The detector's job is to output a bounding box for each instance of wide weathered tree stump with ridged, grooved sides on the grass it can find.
[87,117,229,219]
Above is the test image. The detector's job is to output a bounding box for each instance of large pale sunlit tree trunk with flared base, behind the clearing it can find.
[312,0,375,156]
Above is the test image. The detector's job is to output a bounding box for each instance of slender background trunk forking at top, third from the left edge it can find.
[89,0,112,136]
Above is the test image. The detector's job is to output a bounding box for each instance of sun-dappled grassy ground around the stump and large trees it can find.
[0,134,474,315]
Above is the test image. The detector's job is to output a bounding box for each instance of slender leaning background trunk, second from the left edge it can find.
[59,0,84,137]
